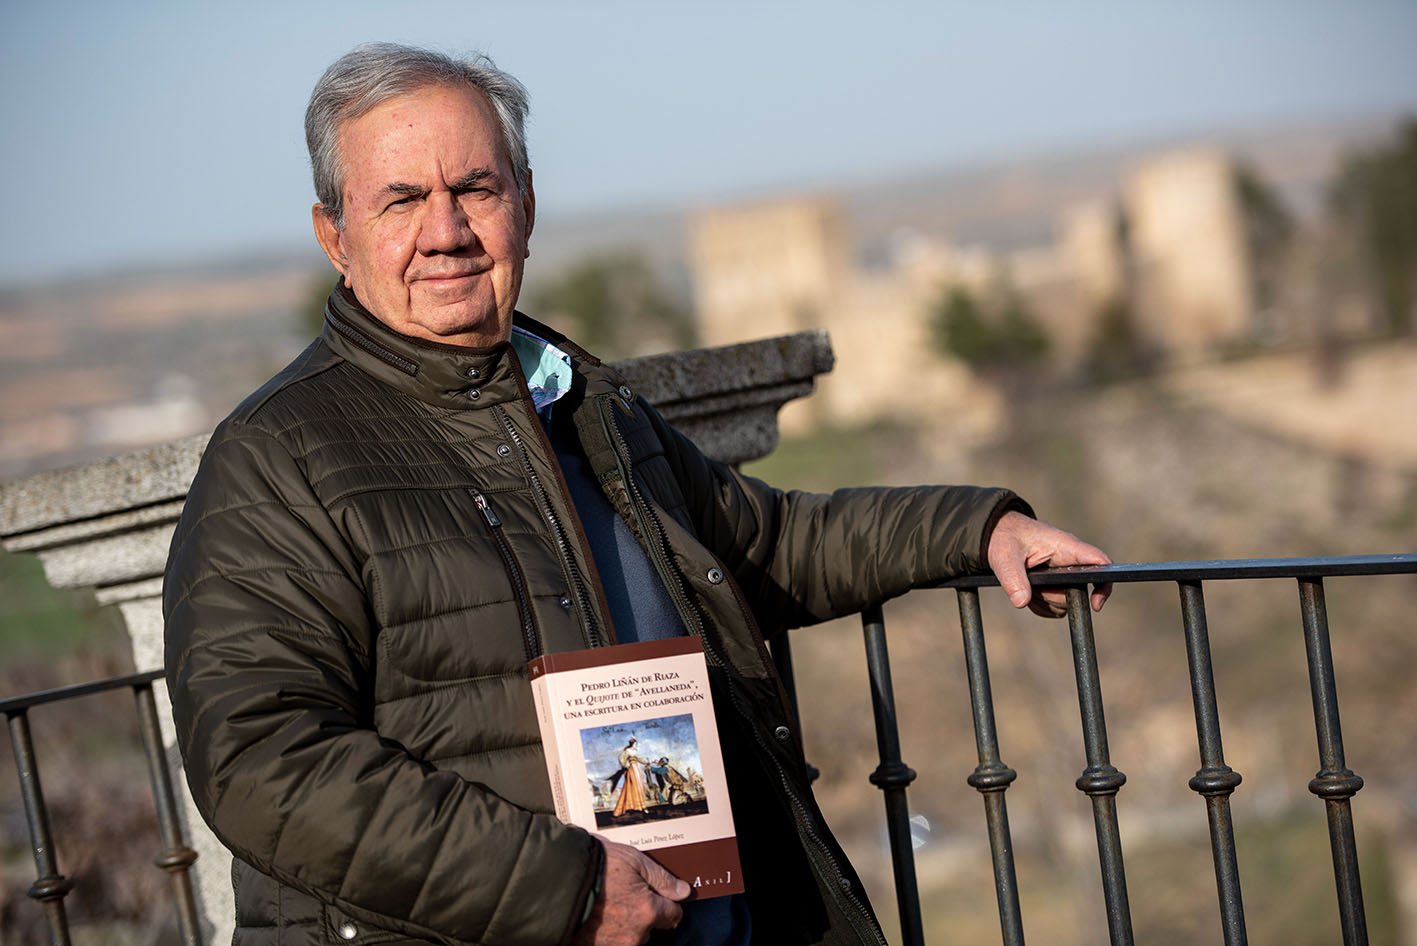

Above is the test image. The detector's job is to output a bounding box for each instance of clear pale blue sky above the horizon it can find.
[0,0,1417,286]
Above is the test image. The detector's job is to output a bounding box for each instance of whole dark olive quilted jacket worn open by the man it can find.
[163,290,1020,946]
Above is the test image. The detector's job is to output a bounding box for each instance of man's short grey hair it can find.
[305,42,531,229]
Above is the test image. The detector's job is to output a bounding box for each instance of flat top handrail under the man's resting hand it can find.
[934,552,1417,588]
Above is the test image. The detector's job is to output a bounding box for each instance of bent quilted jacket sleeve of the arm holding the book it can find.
[163,422,601,946]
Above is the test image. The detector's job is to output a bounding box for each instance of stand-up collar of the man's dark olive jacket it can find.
[322,280,614,411]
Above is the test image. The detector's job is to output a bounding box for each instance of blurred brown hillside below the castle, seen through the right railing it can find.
[752,344,1417,946]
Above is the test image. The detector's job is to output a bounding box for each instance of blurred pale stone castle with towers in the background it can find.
[690,149,1292,428]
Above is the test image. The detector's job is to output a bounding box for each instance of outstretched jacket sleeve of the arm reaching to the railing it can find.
[645,405,1033,632]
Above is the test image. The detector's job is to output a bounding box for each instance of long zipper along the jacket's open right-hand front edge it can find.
[589,398,887,946]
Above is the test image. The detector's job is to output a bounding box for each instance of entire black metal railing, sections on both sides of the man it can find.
[0,555,1417,946]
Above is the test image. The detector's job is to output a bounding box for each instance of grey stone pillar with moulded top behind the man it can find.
[0,331,833,943]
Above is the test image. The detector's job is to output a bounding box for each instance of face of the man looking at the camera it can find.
[315,85,536,347]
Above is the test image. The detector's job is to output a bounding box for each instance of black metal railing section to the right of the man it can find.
[827,555,1417,946]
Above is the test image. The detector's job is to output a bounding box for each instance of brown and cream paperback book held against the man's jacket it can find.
[530,637,743,899]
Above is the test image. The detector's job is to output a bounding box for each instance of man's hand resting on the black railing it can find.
[989,513,1112,617]
